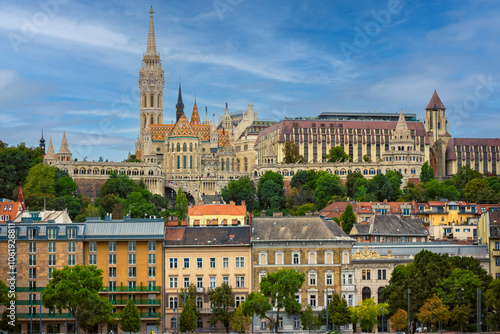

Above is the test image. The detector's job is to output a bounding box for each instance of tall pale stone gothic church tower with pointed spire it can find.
[139,7,165,147]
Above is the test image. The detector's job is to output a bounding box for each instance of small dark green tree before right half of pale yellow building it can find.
[208,284,234,333]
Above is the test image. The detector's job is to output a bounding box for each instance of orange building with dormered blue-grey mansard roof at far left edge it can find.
[0,219,84,333]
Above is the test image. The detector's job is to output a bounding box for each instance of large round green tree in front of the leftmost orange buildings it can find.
[42,264,102,328]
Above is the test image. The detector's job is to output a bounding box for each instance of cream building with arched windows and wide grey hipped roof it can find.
[252,217,355,332]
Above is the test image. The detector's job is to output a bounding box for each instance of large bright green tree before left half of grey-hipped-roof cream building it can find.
[242,269,305,333]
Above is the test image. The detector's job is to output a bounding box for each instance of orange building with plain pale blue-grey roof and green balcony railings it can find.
[80,219,164,334]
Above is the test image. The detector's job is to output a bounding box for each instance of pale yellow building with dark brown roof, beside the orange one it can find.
[164,226,252,332]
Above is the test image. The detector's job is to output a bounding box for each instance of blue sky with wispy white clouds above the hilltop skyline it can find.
[0,0,500,161]
